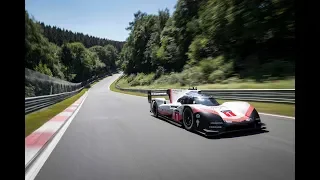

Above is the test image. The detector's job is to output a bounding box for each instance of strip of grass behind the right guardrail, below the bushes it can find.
[118,78,295,89]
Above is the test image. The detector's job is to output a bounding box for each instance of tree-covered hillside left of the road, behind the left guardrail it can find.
[25,12,121,82]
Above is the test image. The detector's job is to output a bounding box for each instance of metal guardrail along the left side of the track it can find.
[24,76,106,115]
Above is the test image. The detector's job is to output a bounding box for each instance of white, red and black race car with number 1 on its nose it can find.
[148,88,266,136]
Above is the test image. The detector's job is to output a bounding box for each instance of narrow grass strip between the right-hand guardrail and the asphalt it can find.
[110,78,295,117]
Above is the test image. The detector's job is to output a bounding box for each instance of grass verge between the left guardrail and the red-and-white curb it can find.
[25,89,88,137]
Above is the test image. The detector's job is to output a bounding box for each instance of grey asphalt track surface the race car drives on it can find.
[36,75,295,180]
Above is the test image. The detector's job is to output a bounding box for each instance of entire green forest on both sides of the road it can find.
[25,0,295,90]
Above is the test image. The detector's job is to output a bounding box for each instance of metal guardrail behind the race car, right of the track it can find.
[116,78,295,104]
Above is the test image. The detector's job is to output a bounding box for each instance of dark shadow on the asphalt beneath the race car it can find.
[151,115,269,139]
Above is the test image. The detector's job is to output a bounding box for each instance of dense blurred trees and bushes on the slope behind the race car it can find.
[119,0,295,85]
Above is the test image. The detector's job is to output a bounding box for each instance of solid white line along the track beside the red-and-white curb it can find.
[25,92,88,180]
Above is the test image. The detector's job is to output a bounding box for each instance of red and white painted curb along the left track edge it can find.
[25,92,88,167]
